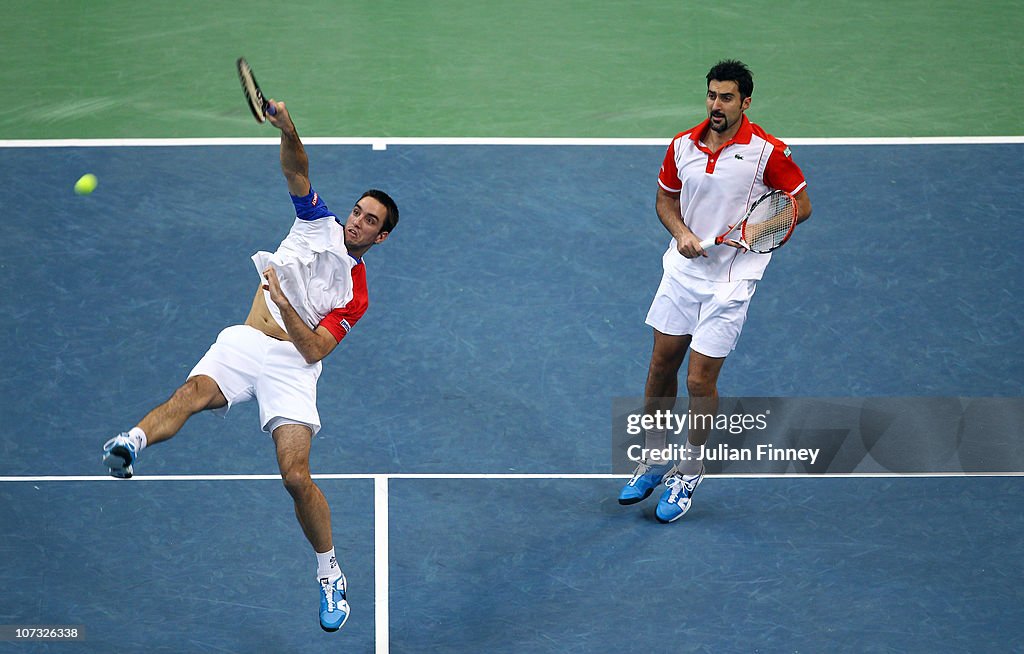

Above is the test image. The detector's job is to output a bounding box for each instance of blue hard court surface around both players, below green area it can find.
[0,143,1024,653]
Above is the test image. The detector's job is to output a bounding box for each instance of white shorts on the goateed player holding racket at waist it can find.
[647,273,758,358]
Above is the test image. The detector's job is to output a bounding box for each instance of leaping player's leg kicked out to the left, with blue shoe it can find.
[103,375,227,479]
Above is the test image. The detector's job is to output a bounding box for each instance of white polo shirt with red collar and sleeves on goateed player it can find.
[657,115,807,281]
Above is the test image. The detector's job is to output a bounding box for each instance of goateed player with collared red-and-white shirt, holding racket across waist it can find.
[618,60,811,522]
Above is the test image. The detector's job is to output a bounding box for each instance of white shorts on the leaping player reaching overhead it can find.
[188,324,323,436]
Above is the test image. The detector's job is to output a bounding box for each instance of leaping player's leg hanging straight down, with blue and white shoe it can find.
[273,424,350,631]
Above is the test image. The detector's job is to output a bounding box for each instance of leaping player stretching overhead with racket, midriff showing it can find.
[103,102,398,631]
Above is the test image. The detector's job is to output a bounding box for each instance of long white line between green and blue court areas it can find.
[0,135,1024,150]
